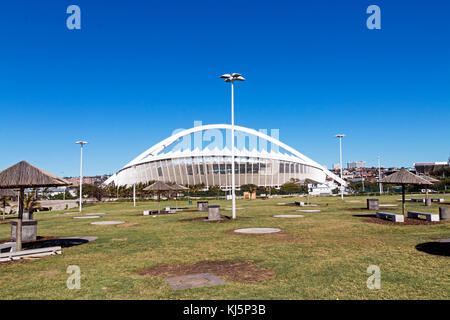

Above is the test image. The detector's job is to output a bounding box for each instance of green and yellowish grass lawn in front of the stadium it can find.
[0,195,450,300]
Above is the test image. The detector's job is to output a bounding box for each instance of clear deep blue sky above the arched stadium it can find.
[0,0,450,176]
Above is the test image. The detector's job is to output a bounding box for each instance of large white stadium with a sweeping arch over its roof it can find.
[105,124,347,190]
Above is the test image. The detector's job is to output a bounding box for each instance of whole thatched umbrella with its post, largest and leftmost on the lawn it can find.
[0,161,70,251]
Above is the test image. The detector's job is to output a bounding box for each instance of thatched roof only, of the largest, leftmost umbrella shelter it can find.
[0,161,70,189]
